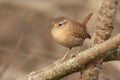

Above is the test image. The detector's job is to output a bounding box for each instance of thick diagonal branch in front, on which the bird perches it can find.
[17,34,120,80]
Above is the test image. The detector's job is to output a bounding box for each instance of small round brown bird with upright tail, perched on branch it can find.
[51,13,92,60]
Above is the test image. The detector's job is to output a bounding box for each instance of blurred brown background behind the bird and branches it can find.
[0,0,120,80]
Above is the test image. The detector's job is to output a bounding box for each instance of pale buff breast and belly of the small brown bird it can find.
[52,30,85,48]
